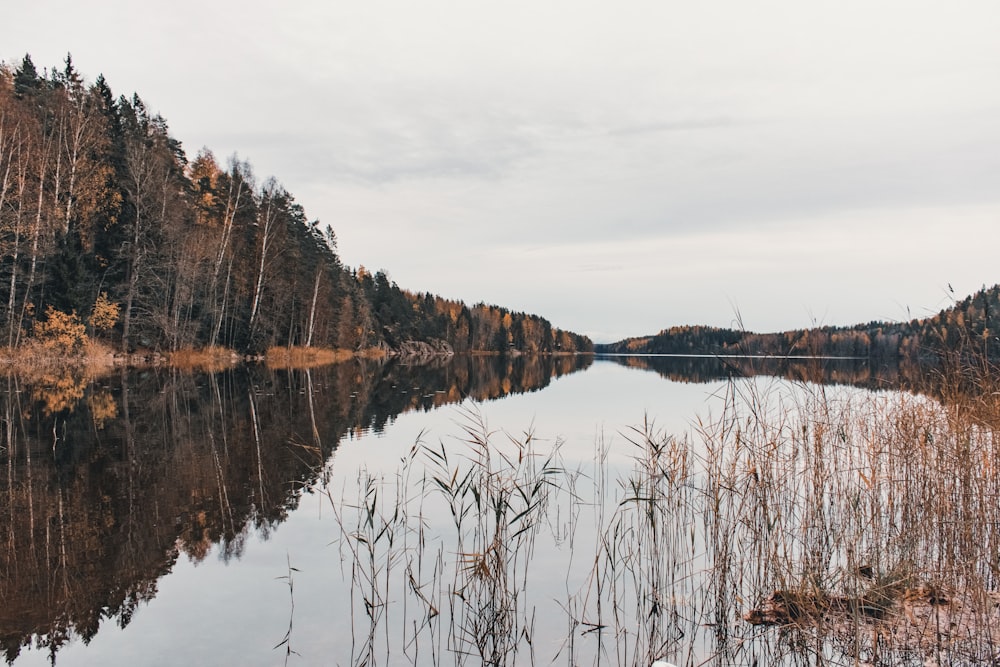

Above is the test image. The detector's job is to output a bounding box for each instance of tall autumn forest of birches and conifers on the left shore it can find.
[0,55,592,354]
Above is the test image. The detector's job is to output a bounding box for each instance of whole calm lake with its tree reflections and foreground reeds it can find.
[0,357,1000,665]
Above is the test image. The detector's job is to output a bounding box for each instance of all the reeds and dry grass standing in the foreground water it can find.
[328,370,1000,665]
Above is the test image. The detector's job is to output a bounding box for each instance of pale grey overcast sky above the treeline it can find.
[0,0,1000,342]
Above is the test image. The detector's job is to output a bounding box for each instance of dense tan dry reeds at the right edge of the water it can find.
[702,383,1000,665]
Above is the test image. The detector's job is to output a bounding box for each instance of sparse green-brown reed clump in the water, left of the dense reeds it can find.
[331,407,562,665]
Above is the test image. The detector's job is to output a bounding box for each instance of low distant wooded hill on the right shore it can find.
[594,285,1000,361]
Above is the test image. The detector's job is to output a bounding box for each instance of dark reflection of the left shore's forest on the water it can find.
[0,357,591,662]
